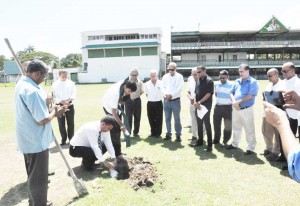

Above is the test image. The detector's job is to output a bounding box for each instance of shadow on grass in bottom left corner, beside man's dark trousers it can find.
[0,182,28,205]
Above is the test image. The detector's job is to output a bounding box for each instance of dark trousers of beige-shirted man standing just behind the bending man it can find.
[125,98,142,135]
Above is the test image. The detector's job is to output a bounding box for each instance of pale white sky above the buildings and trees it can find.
[0,0,300,58]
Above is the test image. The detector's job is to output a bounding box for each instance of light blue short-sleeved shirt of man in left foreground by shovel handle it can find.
[15,77,54,154]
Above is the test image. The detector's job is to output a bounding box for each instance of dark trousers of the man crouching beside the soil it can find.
[69,145,107,169]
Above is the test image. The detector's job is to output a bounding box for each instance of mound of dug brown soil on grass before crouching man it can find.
[115,155,157,190]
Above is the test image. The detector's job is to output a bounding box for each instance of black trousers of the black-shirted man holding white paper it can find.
[195,110,212,148]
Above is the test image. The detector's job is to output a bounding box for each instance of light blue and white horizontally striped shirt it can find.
[215,80,233,105]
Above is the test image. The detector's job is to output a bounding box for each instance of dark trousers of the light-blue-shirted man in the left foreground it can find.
[24,149,49,206]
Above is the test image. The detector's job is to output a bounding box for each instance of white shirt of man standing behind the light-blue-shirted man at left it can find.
[52,79,76,103]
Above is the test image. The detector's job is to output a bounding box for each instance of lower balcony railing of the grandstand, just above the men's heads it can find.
[176,59,300,69]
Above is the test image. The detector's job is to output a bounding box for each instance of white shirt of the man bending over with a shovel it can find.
[102,80,124,114]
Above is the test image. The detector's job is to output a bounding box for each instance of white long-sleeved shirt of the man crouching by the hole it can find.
[70,121,116,162]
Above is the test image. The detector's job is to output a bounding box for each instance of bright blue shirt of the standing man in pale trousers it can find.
[230,76,258,108]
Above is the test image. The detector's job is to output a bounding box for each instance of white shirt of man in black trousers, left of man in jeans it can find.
[145,79,163,102]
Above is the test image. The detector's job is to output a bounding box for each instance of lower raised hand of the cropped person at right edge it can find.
[263,102,290,128]
